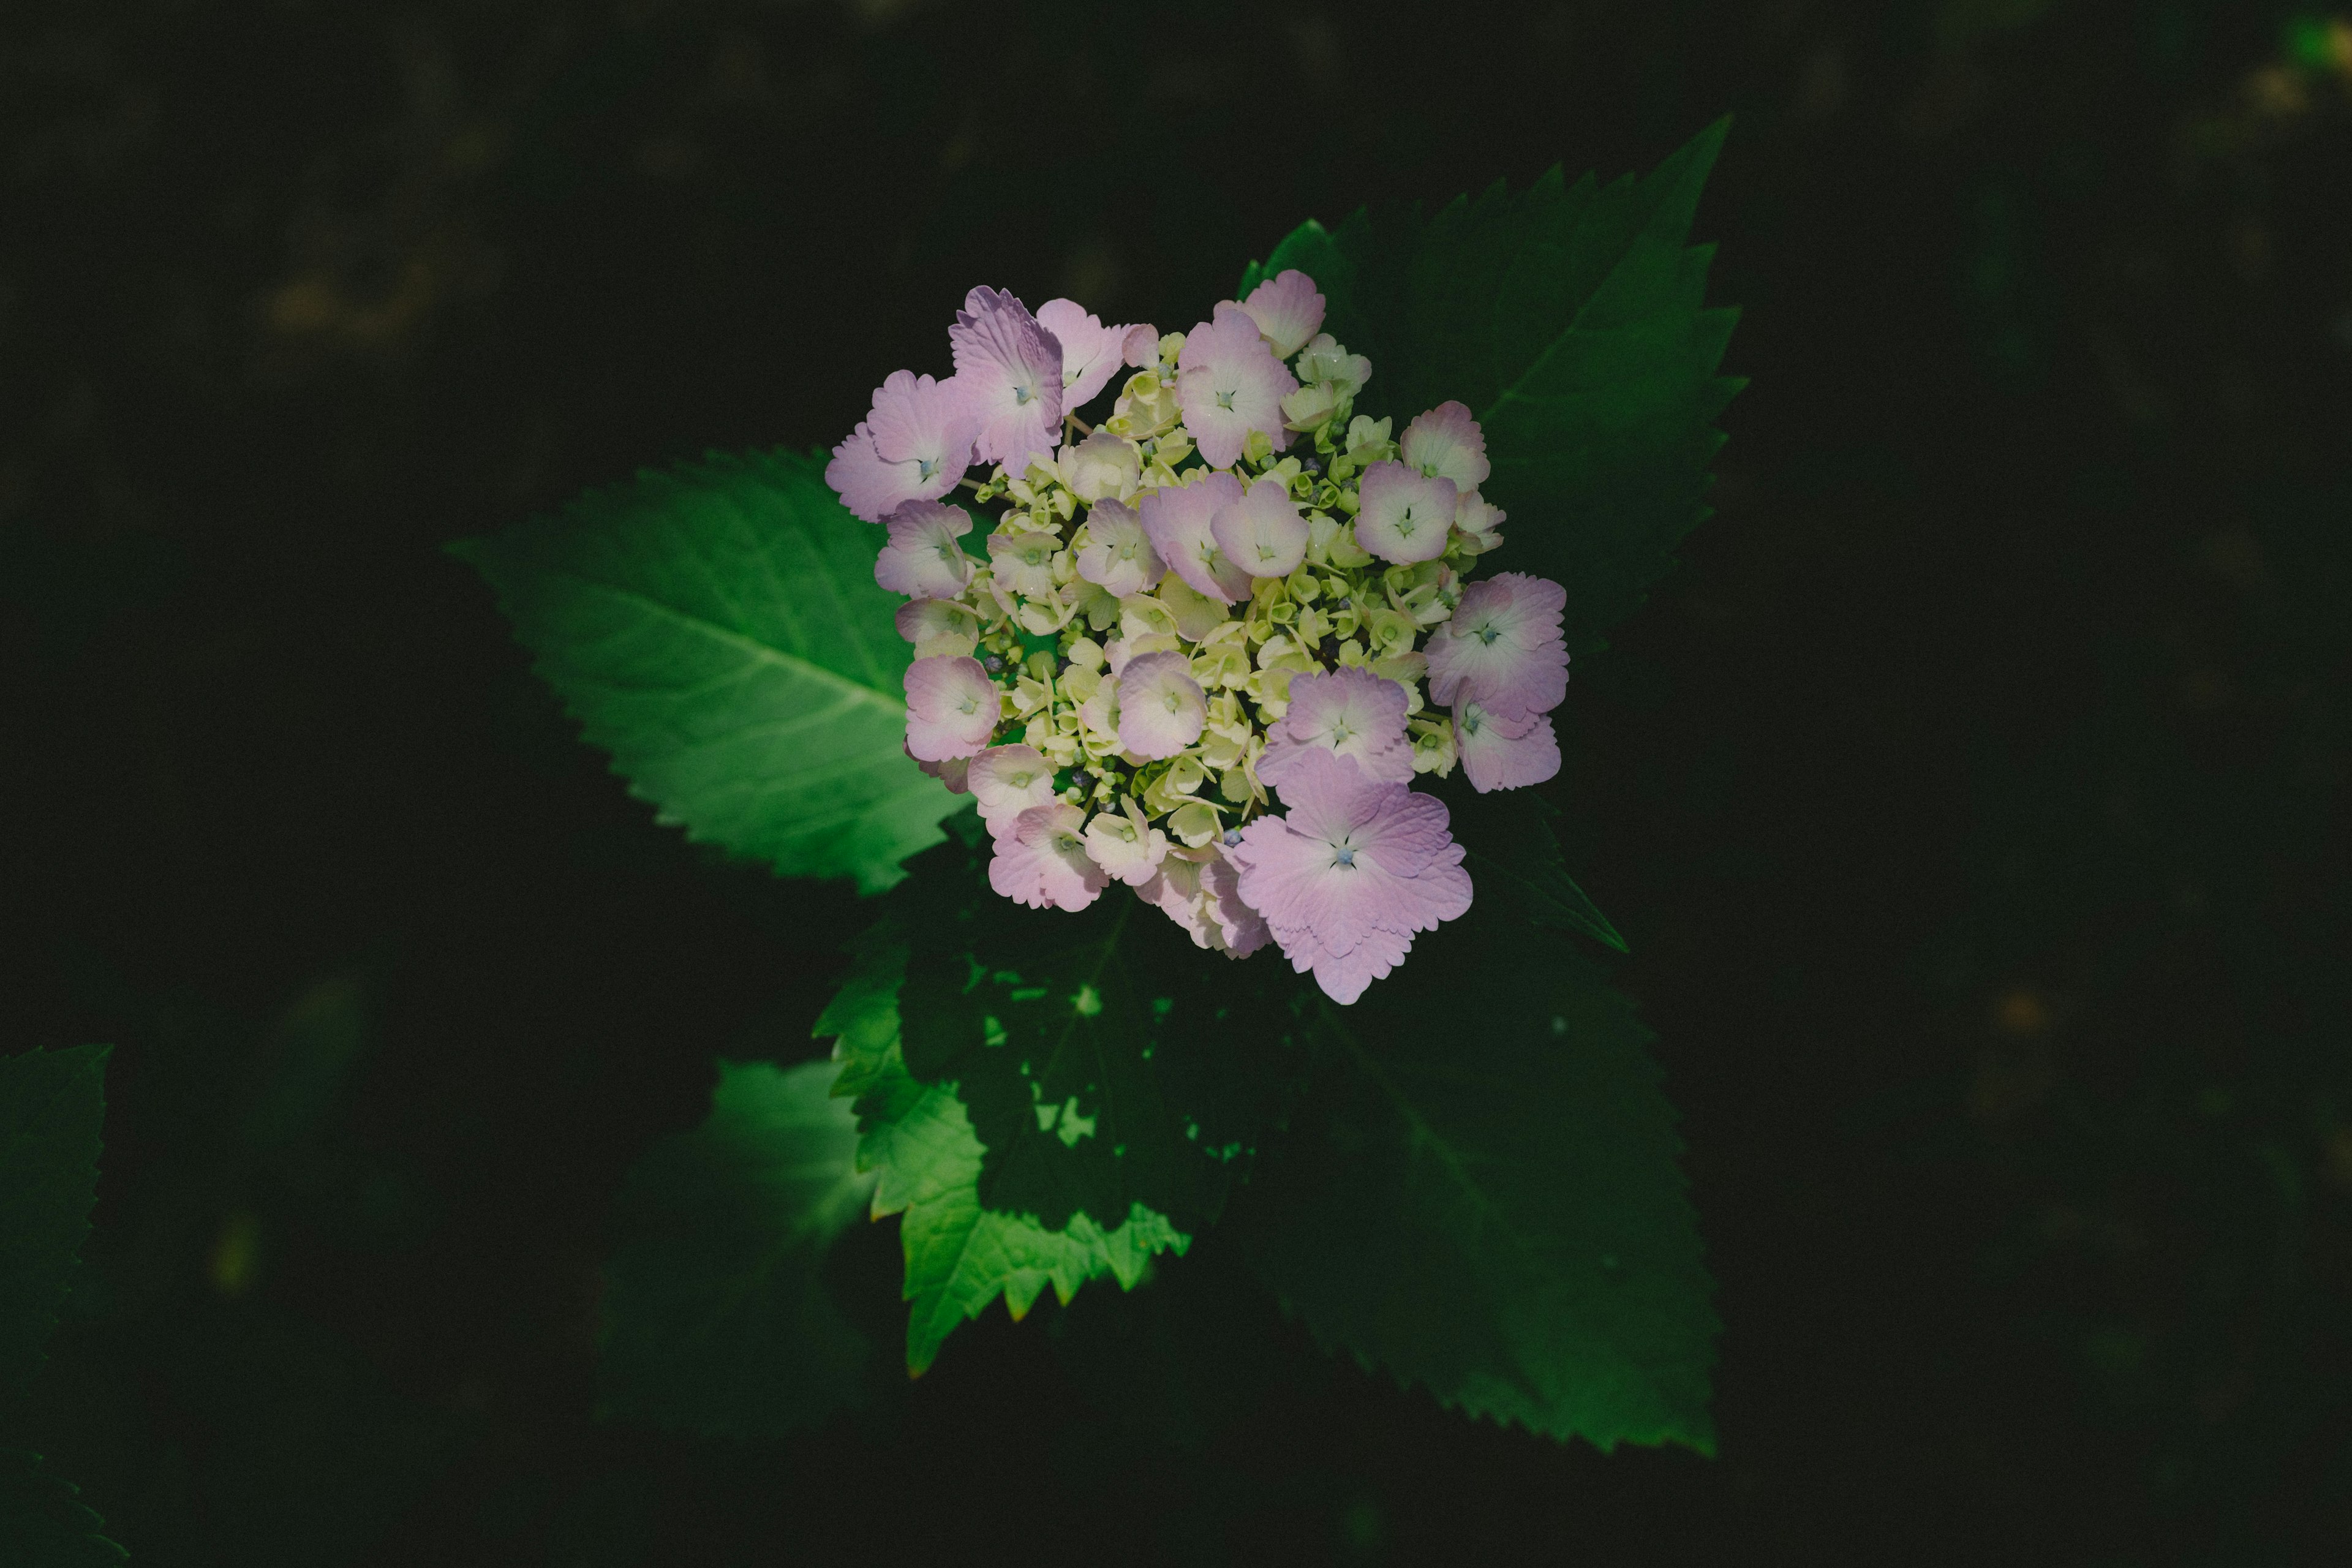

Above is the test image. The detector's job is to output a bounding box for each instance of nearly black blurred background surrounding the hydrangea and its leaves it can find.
[0,0,2352,1566]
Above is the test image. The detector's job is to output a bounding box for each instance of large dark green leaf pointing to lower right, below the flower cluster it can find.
[1226,924,1717,1453]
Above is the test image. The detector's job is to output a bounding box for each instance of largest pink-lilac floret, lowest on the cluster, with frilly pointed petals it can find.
[1226,752,1470,1004]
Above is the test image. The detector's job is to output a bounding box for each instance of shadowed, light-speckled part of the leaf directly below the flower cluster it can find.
[891,846,1313,1229]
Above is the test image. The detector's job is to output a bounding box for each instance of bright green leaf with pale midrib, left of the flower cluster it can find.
[451,451,962,891]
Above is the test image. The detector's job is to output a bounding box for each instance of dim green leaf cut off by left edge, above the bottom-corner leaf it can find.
[0,1046,113,1406]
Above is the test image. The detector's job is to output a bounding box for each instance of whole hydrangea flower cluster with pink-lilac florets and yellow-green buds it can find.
[826,270,1569,1001]
